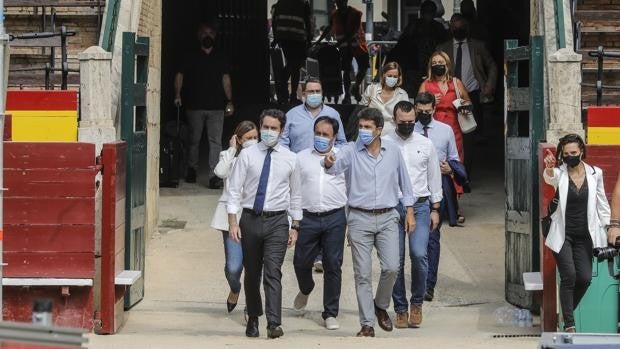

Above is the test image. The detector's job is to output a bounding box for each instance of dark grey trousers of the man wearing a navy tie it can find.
[239,212,289,326]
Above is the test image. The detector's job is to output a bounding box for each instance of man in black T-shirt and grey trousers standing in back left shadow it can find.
[174,21,235,189]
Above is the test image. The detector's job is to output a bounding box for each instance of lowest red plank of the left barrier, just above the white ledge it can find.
[3,252,95,279]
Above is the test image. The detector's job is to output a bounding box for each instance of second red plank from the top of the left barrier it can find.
[4,168,97,198]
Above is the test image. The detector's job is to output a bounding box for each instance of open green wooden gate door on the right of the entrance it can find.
[504,36,544,308]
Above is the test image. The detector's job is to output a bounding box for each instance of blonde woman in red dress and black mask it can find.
[420,51,471,163]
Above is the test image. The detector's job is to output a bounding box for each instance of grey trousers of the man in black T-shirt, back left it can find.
[187,110,224,176]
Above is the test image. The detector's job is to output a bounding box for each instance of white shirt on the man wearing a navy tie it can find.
[226,142,302,220]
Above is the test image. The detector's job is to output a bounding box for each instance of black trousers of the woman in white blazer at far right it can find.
[555,232,592,328]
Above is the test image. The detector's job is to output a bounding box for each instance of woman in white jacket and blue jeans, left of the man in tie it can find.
[211,121,258,313]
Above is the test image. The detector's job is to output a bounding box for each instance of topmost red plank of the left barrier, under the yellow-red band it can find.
[4,142,96,169]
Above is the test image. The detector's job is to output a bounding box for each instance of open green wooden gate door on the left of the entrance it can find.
[121,32,149,308]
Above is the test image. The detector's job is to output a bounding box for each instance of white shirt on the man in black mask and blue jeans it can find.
[383,132,443,204]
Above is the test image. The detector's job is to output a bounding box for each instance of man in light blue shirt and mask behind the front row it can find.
[280,78,347,153]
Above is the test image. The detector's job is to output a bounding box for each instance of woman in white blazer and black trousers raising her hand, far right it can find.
[543,134,610,332]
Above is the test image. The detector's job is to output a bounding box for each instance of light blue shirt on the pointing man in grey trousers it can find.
[321,139,417,210]
